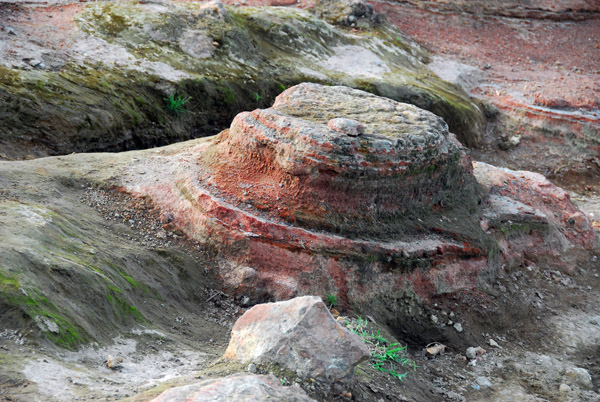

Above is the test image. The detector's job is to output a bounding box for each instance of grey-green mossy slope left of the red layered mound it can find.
[0,154,219,349]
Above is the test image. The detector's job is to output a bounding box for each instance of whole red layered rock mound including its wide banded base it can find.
[117,84,596,326]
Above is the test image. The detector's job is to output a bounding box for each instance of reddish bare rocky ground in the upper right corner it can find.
[374,1,600,193]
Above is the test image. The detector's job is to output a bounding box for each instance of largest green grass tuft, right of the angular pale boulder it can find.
[344,317,417,380]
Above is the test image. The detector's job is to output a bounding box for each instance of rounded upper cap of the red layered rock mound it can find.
[204,84,477,238]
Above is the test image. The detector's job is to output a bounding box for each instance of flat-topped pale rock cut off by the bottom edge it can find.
[152,374,314,402]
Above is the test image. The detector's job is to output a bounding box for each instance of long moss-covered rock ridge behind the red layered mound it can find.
[0,2,484,158]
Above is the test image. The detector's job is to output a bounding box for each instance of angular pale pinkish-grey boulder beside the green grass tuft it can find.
[224,296,371,382]
